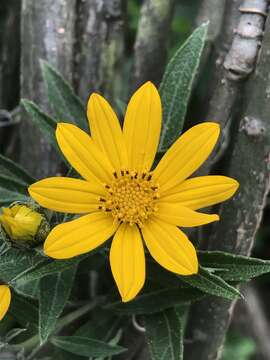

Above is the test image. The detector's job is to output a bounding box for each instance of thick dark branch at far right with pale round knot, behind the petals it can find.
[185,6,270,360]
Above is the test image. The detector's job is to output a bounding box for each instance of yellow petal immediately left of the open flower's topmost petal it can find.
[87,94,127,171]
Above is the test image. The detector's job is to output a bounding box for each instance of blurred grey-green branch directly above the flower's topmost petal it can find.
[132,0,175,90]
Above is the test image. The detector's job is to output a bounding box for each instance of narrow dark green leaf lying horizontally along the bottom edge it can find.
[51,336,126,357]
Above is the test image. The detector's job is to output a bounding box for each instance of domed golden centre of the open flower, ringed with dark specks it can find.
[99,170,159,227]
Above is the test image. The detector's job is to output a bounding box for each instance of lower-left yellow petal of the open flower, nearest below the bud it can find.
[44,211,118,259]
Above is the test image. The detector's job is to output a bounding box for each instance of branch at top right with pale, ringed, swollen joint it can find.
[200,0,268,174]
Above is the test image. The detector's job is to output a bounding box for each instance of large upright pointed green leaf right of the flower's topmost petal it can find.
[159,24,208,151]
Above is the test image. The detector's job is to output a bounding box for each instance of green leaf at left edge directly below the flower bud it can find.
[0,248,46,288]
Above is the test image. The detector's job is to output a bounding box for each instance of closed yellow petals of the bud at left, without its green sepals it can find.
[0,204,42,241]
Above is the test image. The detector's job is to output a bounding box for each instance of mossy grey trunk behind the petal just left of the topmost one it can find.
[74,0,125,101]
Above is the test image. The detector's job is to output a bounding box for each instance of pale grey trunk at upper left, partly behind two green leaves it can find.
[21,0,75,177]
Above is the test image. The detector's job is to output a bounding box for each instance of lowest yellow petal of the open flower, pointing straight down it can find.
[110,224,145,302]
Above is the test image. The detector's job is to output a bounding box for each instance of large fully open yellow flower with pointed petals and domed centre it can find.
[29,82,238,301]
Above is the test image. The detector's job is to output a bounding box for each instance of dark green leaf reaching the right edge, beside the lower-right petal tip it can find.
[198,251,270,282]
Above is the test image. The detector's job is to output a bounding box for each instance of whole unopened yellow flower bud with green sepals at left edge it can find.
[0,202,50,246]
